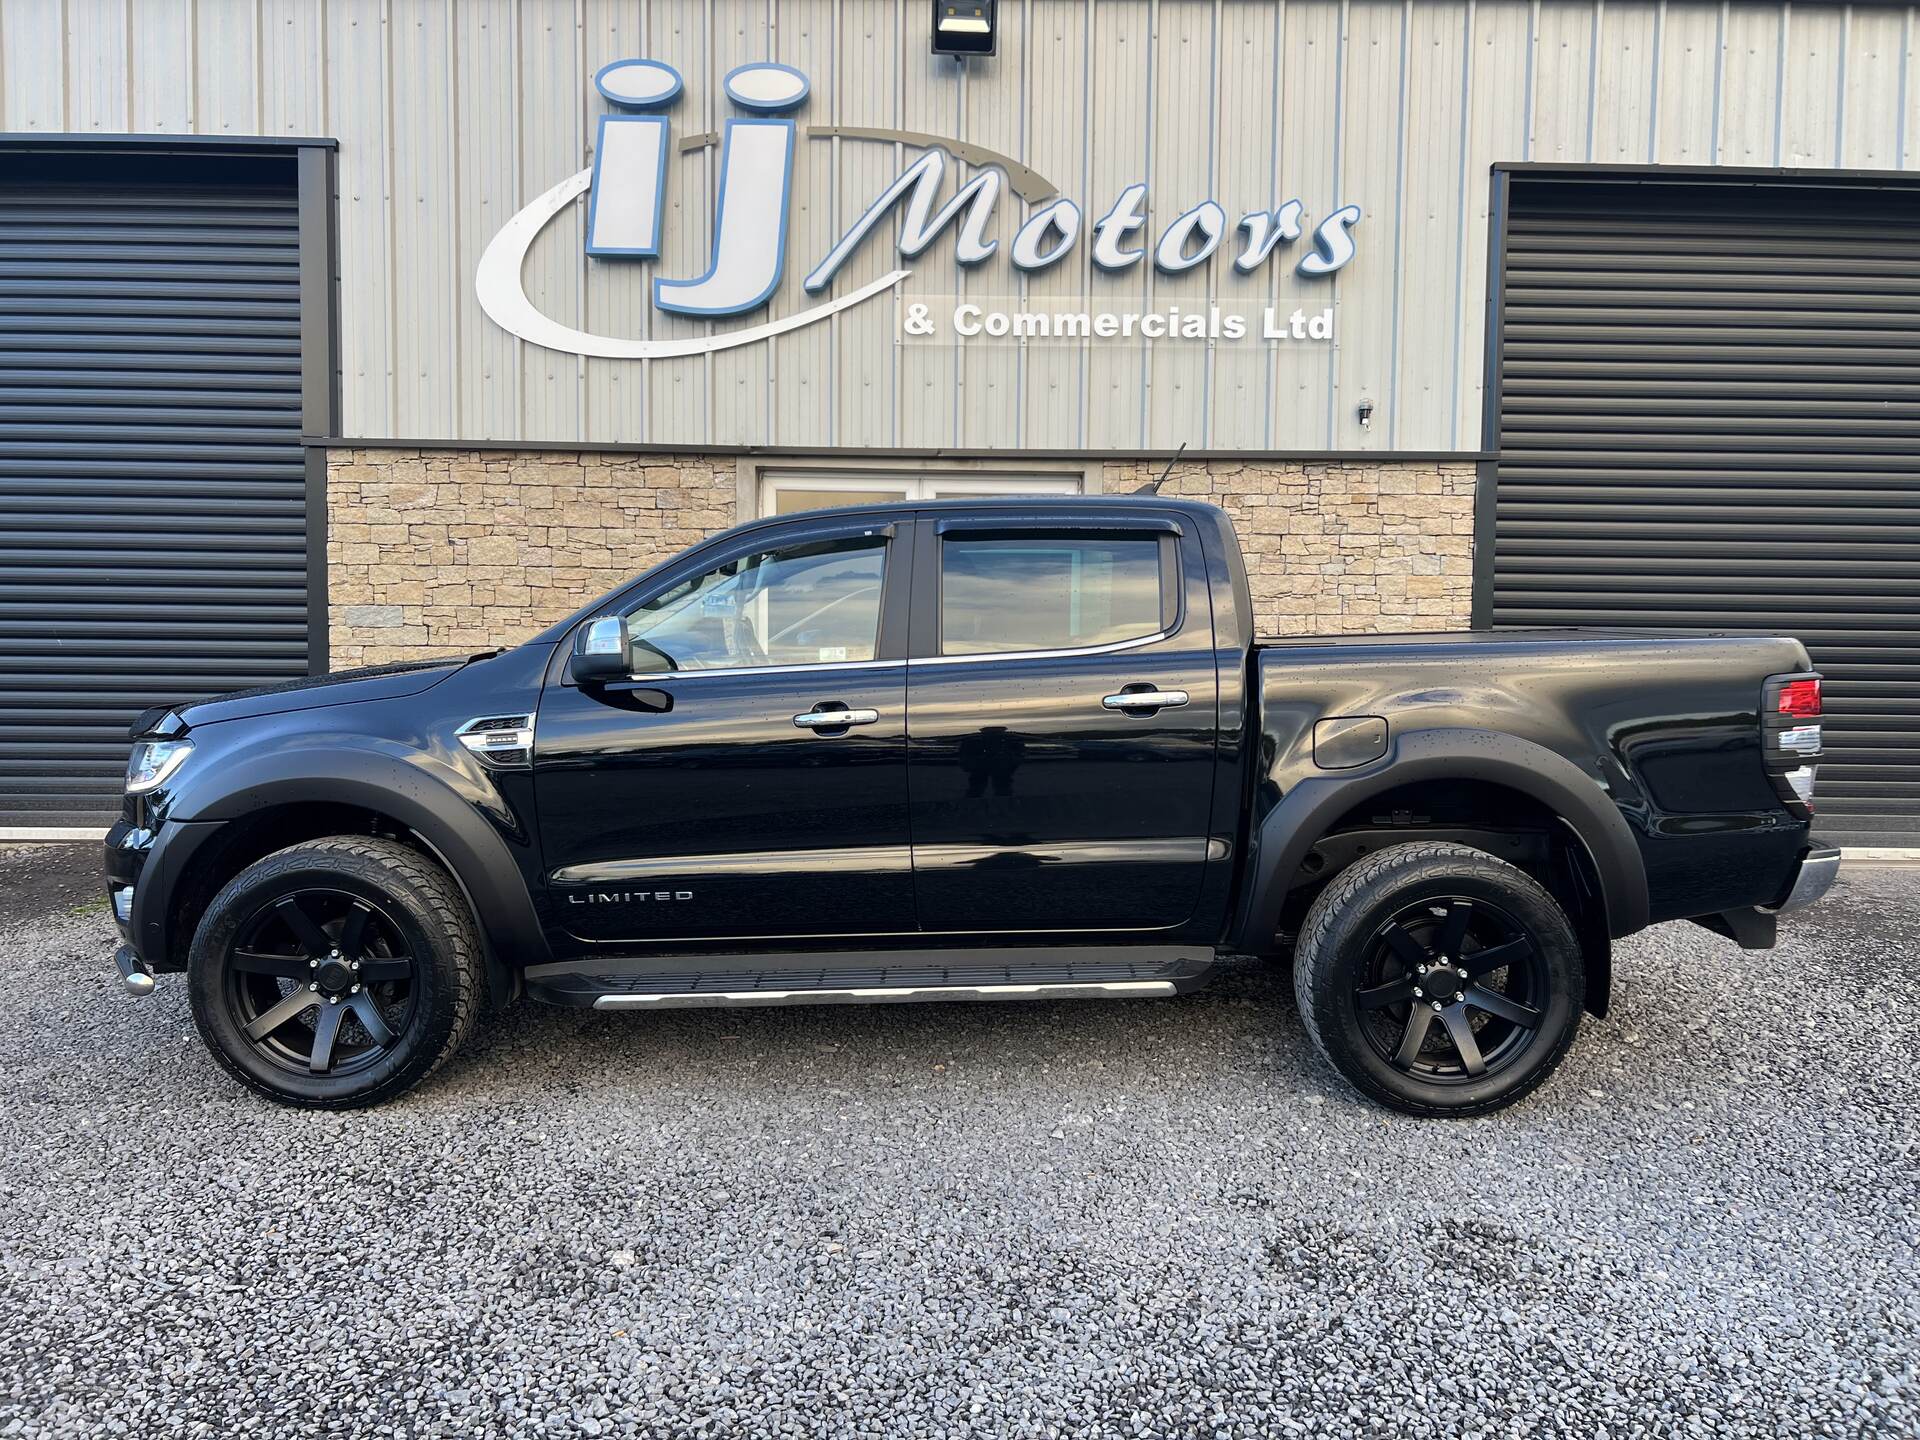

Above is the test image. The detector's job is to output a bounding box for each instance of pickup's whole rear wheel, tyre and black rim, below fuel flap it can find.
[1294,841,1584,1116]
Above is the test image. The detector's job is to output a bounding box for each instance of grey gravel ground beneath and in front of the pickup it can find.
[0,852,1920,1440]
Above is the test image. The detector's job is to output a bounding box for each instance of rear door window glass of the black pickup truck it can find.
[941,536,1164,655]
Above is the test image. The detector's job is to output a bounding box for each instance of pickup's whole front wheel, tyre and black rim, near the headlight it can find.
[186,835,484,1110]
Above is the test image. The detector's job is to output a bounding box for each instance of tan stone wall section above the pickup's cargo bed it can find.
[1106,457,1475,636]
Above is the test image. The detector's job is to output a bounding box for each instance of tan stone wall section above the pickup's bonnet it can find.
[326,449,737,670]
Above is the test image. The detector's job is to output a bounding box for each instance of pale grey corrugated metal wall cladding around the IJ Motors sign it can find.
[18,0,1920,451]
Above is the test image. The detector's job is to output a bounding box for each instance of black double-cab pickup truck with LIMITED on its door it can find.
[106,495,1839,1116]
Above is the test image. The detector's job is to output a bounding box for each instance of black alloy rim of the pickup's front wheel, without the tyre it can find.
[227,887,417,1075]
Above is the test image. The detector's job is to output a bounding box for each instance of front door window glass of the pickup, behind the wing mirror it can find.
[626,536,887,670]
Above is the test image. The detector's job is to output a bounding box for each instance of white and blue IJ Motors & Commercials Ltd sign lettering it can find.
[474,60,1359,359]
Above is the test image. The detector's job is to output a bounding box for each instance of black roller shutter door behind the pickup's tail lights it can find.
[1492,173,1920,845]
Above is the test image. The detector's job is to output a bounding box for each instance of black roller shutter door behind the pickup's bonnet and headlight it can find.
[0,156,307,828]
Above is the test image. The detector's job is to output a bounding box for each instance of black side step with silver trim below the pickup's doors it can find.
[526,947,1213,1010]
